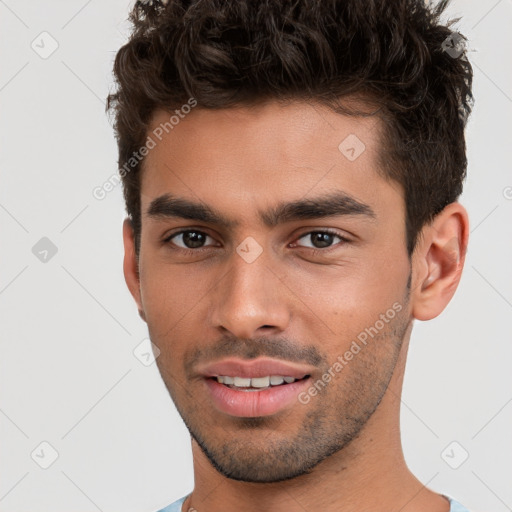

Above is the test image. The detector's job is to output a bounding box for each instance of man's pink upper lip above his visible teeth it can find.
[199,358,312,379]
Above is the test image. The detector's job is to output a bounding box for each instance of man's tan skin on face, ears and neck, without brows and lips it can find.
[123,102,469,512]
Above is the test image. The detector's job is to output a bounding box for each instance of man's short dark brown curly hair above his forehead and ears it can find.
[106,0,473,257]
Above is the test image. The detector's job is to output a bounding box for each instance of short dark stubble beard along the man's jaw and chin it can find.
[162,301,410,483]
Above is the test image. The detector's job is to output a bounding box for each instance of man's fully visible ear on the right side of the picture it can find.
[411,202,469,320]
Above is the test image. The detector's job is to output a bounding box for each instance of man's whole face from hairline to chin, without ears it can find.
[127,102,411,482]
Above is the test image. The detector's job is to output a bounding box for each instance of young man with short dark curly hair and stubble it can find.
[109,0,472,512]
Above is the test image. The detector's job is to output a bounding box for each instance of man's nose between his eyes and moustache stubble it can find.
[212,248,290,339]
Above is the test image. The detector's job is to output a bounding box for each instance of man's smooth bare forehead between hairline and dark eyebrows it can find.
[141,102,399,225]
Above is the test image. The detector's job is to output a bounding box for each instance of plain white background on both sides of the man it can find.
[0,0,512,512]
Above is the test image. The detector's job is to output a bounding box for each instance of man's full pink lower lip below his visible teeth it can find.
[205,377,309,418]
